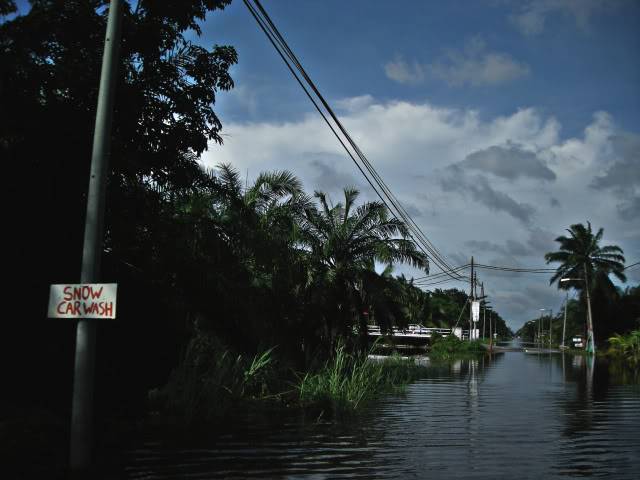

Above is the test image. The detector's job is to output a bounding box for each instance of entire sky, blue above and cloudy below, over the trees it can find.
[198,0,640,329]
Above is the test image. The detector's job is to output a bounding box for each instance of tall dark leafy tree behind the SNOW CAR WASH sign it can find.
[0,0,237,416]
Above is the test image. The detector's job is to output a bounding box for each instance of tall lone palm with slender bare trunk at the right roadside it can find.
[544,222,627,352]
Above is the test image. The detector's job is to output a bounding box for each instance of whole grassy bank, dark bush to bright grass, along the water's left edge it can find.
[148,333,486,428]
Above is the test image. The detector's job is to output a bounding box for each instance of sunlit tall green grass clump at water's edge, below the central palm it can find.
[297,343,422,411]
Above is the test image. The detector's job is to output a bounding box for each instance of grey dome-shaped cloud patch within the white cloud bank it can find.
[458,144,556,181]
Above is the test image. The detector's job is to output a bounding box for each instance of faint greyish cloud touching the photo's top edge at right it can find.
[509,0,621,35]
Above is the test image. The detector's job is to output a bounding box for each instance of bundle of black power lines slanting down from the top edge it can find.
[244,0,462,279]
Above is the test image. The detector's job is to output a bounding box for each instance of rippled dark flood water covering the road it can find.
[126,344,640,479]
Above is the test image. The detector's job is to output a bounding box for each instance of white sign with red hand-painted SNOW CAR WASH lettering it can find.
[47,283,118,318]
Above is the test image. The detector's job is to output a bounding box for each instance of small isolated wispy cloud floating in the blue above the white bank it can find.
[385,37,530,87]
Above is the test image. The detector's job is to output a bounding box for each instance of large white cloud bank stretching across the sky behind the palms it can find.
[203,97,640,328]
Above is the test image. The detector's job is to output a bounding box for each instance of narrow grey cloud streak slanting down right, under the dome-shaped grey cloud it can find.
[440,173,535,224]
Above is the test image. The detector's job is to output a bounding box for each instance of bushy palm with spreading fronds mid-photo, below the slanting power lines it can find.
[299,188,429,348]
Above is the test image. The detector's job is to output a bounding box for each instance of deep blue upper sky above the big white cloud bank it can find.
[202,0,640,135]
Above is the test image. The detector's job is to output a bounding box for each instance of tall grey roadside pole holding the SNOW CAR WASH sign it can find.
[69,0,122,473]
